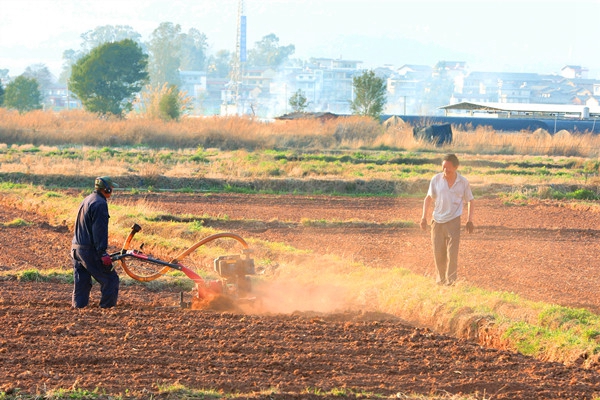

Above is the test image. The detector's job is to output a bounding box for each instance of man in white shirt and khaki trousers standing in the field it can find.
[421,154,473,285]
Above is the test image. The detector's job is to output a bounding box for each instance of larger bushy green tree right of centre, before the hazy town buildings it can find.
[350,70,386,119]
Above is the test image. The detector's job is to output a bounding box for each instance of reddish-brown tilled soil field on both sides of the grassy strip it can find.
[0,194,600,399]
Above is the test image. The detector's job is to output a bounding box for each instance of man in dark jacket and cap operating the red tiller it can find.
[71,176,119,308]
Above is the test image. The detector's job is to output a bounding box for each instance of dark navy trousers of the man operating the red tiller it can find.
[71,247,119,308]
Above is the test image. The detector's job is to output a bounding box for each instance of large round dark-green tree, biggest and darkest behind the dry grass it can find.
[69,39,148,116]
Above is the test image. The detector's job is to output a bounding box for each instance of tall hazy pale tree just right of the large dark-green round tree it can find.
[148,22,181,87]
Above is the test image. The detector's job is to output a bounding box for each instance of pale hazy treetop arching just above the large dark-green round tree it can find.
[58,25,144,83]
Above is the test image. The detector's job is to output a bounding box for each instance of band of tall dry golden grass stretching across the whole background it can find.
[0,108,600,157]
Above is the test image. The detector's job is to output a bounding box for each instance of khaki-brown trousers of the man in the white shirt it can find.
[431,217,460,285]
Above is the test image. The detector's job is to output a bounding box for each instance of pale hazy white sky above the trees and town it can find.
[0,0,600,79]
